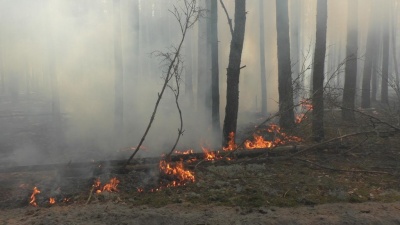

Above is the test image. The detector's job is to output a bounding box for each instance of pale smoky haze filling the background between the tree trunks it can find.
[0,0,399,164]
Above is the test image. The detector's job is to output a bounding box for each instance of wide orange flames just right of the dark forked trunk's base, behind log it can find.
[244,124,302,149]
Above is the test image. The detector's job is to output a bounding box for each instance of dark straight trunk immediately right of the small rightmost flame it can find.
[312,0,328,141]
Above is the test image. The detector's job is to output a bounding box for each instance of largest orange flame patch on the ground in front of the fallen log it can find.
[159,160,195,187]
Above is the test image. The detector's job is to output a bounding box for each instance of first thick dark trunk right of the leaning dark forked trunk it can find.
[276,0,295,129]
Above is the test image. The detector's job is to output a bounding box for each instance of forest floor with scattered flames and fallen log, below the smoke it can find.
[0,108,400,224]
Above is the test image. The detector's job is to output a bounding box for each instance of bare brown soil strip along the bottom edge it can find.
[0,202,400,225]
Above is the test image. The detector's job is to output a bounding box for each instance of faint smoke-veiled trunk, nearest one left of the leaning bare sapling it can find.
[113,0,124,137]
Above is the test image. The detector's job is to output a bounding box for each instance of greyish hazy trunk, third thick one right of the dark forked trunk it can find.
[342,0,358,121]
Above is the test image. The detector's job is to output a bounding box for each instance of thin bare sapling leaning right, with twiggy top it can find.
[123,0,203,168]
